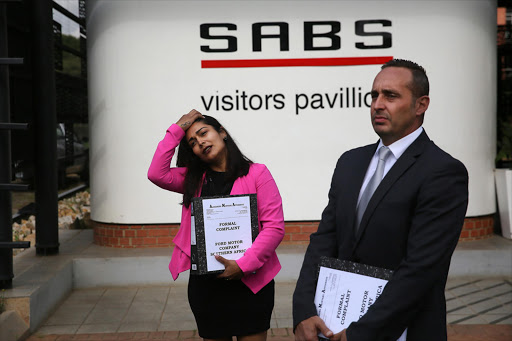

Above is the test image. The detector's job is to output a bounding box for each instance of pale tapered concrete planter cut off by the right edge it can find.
[494,169,512,239]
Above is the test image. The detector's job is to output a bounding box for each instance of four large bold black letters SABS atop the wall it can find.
[200,19,392,53]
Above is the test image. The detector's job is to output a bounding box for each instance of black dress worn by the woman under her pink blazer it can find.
[188,171,274,339]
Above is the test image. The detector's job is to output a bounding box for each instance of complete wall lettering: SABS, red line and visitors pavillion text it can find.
[200,19,392,115]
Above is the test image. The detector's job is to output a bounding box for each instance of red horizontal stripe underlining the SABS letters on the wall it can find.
[201,56,393,69]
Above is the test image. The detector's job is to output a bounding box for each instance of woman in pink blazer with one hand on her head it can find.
[148,110,284,341]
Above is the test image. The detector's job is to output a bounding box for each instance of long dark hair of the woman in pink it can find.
[176,115,252,207]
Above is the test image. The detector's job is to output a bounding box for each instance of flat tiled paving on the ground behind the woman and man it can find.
[30,277,512,341]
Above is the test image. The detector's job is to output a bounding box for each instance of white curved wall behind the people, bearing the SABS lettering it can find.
[87,0,496,224]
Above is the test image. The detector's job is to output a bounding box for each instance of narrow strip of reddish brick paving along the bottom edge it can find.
[27,324,512,341]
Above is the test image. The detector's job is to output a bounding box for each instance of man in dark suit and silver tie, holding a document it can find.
[293,59,468,341]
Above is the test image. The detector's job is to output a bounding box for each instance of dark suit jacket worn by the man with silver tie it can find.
[293,132,468,341]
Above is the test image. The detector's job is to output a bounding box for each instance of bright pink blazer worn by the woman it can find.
[148,124,284,293]
